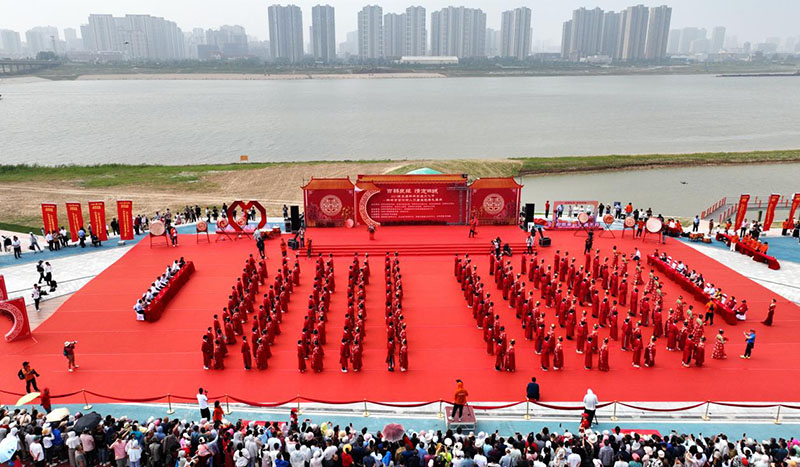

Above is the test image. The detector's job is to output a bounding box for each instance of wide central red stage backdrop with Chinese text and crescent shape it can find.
[356,174,469,225]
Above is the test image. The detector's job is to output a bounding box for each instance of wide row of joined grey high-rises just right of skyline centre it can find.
[431,7,486,58]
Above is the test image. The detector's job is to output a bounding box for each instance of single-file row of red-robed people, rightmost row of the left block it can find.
[383,251,408,372]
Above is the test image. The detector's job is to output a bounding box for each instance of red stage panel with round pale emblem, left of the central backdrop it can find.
[303,177,355,227]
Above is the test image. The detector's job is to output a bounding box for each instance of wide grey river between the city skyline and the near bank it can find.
[0,75,800,165]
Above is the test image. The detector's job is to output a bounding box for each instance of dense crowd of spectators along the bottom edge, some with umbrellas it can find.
[0,409,800,467]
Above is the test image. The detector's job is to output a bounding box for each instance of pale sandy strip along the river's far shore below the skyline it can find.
[77,73,446,81]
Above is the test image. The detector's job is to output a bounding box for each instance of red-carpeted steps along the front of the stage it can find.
[312,241,525,256]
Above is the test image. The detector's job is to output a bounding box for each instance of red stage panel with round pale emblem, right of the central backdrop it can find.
[469,177,522,225]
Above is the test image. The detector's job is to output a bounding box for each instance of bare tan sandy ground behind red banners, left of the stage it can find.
[0,162,404,226]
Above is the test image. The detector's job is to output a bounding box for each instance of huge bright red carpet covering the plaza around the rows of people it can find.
[0,226,800,402]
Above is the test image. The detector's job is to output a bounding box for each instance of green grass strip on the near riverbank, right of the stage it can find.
[513,149,800,175]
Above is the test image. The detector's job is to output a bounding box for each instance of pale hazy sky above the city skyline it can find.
[0,0,800,44]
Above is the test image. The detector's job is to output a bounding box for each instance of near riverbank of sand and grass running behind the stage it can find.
[0,150,800,231]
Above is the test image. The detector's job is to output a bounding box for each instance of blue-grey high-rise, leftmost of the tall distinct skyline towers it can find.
[267,5,303,63]
